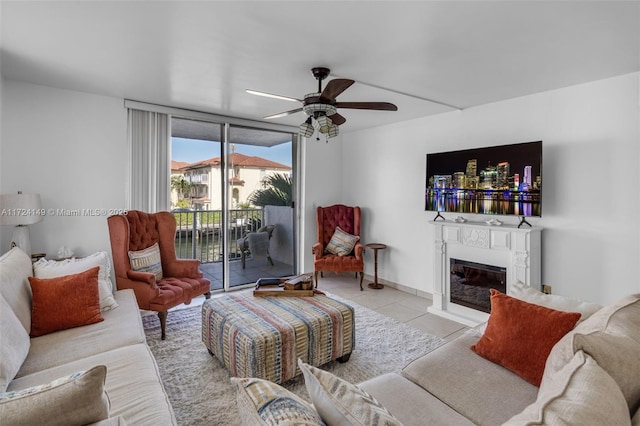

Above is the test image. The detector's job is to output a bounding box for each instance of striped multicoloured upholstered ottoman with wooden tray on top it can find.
[202,293,355,383]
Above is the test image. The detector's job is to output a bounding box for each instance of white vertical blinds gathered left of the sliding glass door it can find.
[128,108,171,213]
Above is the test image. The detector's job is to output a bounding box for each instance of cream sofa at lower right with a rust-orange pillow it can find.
[359,288,640,426]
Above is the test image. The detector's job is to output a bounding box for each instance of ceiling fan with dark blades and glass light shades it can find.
[247,67,398,139]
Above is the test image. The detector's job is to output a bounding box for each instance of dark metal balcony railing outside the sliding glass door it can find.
[173,209,263,263]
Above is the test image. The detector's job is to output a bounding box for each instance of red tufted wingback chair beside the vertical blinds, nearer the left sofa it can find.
[107,210,211,340]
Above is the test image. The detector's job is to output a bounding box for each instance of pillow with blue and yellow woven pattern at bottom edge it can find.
[231,377,324,426]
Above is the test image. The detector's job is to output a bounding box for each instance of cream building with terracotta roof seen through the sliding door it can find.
[171,153,291,210]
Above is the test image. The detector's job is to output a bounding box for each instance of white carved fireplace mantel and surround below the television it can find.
[429,220,542,327]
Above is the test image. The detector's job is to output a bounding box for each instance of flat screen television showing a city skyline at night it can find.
[425,141,542,220]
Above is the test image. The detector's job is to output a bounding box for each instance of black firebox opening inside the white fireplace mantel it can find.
[449,258,507,313]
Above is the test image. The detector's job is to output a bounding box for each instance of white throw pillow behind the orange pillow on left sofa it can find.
[33,251,118,312]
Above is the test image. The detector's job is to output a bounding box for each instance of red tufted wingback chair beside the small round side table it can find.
[312,204,364,290]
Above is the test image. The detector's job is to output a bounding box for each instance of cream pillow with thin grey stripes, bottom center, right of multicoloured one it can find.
[298,360,402,426]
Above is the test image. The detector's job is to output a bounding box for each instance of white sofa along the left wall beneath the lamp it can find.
[0,248,176,425]
